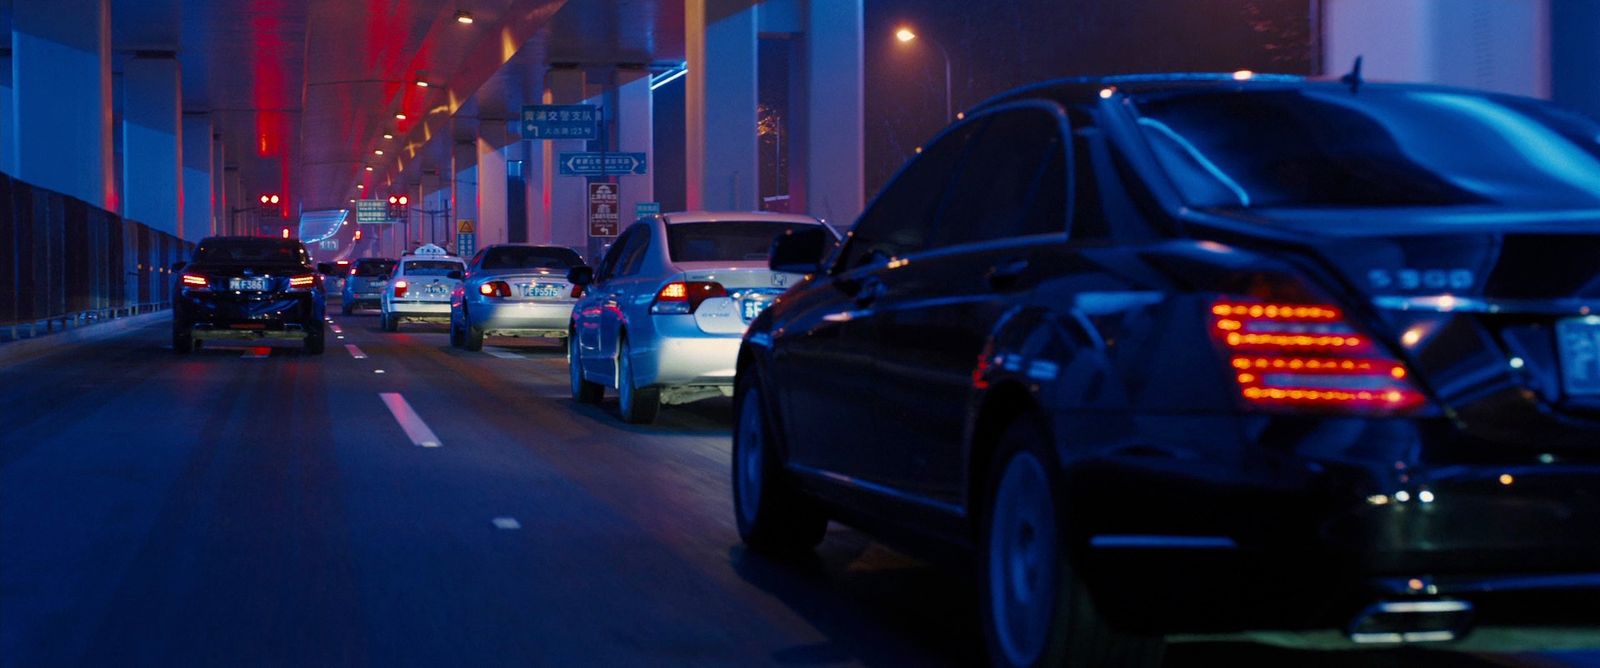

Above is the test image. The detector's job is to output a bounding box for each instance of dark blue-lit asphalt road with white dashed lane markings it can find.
[0,308,1600,666]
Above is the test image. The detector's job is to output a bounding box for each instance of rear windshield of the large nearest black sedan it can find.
[1134,86,1600,208]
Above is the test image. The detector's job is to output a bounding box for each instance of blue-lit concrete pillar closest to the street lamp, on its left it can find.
[789,0,867,227]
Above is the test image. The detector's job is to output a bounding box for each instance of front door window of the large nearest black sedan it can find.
[834,121,981,272]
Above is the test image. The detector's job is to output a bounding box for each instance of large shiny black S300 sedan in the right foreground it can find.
[733,72,1600,666]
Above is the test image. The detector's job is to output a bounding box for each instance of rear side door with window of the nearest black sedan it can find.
[877,102,1070,508]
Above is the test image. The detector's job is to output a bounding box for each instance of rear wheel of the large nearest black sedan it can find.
[978,417,1165,668]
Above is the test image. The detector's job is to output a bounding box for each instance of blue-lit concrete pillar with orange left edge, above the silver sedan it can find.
[685,0,760,211]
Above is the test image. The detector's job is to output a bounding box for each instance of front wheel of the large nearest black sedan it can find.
[733,372,827,555]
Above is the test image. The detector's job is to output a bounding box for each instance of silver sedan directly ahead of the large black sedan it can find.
[568,213,837,422]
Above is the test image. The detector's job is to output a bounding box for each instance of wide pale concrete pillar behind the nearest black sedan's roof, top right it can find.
[1323,0,1550,97]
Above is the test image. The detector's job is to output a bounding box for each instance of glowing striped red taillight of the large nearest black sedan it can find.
[1211,300,1422,412]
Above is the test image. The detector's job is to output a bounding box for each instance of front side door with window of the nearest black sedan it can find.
[773,123,976,484]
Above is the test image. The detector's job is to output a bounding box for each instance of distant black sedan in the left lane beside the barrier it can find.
[173,237,325,355]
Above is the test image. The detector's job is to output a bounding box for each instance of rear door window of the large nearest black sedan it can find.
[930,109,1067,248]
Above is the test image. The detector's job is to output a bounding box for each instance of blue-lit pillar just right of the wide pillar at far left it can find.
[122,56,183,237]
